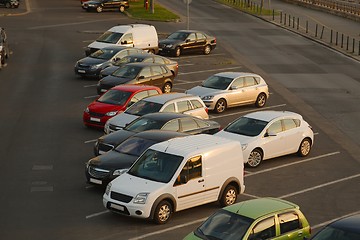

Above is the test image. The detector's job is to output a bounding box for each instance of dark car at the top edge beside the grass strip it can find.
[81,0,129,13]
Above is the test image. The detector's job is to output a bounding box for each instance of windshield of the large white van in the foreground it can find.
[127,149,183,183]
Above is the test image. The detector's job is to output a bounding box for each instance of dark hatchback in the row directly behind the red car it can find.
[97,62,174,94]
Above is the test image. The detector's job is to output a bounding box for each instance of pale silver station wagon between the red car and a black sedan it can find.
[104,93,209,134]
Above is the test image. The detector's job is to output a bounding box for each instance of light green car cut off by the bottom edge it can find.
[184,198,311,240]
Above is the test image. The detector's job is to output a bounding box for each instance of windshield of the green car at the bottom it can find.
[194,209,254,240]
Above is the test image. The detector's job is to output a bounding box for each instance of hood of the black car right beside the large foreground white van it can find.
[90,150,138,171]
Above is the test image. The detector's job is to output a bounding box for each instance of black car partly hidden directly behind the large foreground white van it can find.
[85,130,188,186]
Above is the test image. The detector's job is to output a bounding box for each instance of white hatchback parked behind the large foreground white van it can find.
[215,111,314,167]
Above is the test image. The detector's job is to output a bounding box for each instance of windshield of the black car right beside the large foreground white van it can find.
[115,137,157,157]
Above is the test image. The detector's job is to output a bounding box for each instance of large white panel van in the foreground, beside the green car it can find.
[103,134,245,224]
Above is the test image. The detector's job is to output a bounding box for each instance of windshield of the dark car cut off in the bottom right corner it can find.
[312,226,360,240]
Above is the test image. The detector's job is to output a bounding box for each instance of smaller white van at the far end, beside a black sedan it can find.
[85,24,159,56]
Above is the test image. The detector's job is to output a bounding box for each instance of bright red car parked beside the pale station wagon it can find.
[83,84,162,128]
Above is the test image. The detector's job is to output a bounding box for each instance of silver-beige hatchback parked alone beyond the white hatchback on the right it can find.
[186,72,269,113]
